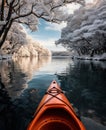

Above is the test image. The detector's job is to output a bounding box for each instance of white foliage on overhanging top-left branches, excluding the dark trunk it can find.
[0,0,83,30]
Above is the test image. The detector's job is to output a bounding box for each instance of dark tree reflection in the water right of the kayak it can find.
[57,61,106,125]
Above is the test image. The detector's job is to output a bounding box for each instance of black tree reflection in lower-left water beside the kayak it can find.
[0,73,44,130]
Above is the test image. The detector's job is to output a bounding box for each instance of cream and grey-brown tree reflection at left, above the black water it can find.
[0,57,51,98]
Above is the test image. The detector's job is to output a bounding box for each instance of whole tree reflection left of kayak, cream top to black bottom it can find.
[0,57,50,130]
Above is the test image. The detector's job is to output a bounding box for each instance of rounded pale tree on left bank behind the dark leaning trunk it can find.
[1,23,28,54]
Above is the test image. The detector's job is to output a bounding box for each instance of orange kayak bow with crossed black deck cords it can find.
[27,81,85,130]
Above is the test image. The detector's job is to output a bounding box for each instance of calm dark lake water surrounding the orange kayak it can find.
[0,57,106,130]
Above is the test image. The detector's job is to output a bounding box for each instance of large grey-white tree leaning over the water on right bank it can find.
[56,0,106,57]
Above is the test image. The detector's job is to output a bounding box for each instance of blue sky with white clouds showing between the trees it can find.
[26,0,93,51]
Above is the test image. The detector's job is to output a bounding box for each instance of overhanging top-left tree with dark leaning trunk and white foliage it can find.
[0,0,84,48]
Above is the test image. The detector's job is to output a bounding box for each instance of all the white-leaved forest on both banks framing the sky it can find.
[0,0,106,60]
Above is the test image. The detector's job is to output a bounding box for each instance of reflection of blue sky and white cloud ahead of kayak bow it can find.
[28,58,73,91]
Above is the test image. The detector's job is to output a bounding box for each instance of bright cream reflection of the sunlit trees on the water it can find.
[14,57,51,80]
